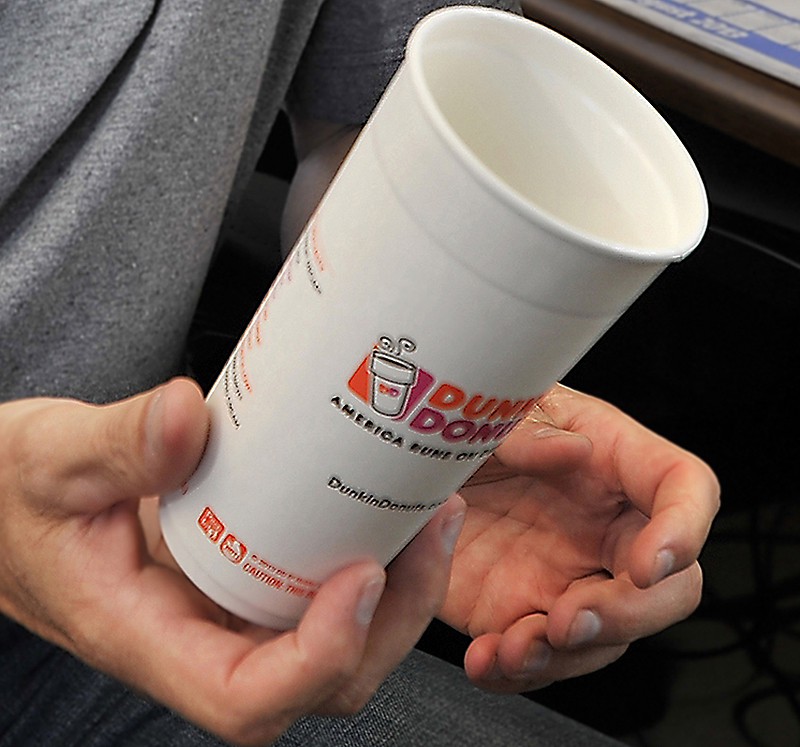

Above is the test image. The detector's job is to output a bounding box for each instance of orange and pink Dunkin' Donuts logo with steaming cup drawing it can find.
[347,335,536,444]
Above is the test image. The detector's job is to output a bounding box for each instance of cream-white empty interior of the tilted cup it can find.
[414,9,707,254]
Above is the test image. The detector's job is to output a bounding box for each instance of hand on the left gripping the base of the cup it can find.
[0,380,463,744]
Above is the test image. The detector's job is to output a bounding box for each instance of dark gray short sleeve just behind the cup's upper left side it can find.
[287,0,521,124]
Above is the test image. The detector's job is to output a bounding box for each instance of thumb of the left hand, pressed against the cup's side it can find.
[13,379,209,514]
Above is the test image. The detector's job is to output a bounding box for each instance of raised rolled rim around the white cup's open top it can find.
[406,5,709,264]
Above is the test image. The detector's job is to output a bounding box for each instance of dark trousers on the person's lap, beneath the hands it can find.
[0,617,617,747]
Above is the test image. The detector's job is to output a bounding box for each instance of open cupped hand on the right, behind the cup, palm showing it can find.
[440,386,719,691]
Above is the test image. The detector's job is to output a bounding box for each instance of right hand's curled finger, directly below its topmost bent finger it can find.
[547,562,702,650]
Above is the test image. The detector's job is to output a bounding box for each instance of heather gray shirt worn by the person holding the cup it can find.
[0,0,516,402]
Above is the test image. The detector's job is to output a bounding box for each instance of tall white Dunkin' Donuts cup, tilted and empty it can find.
[161,7,707,628]
